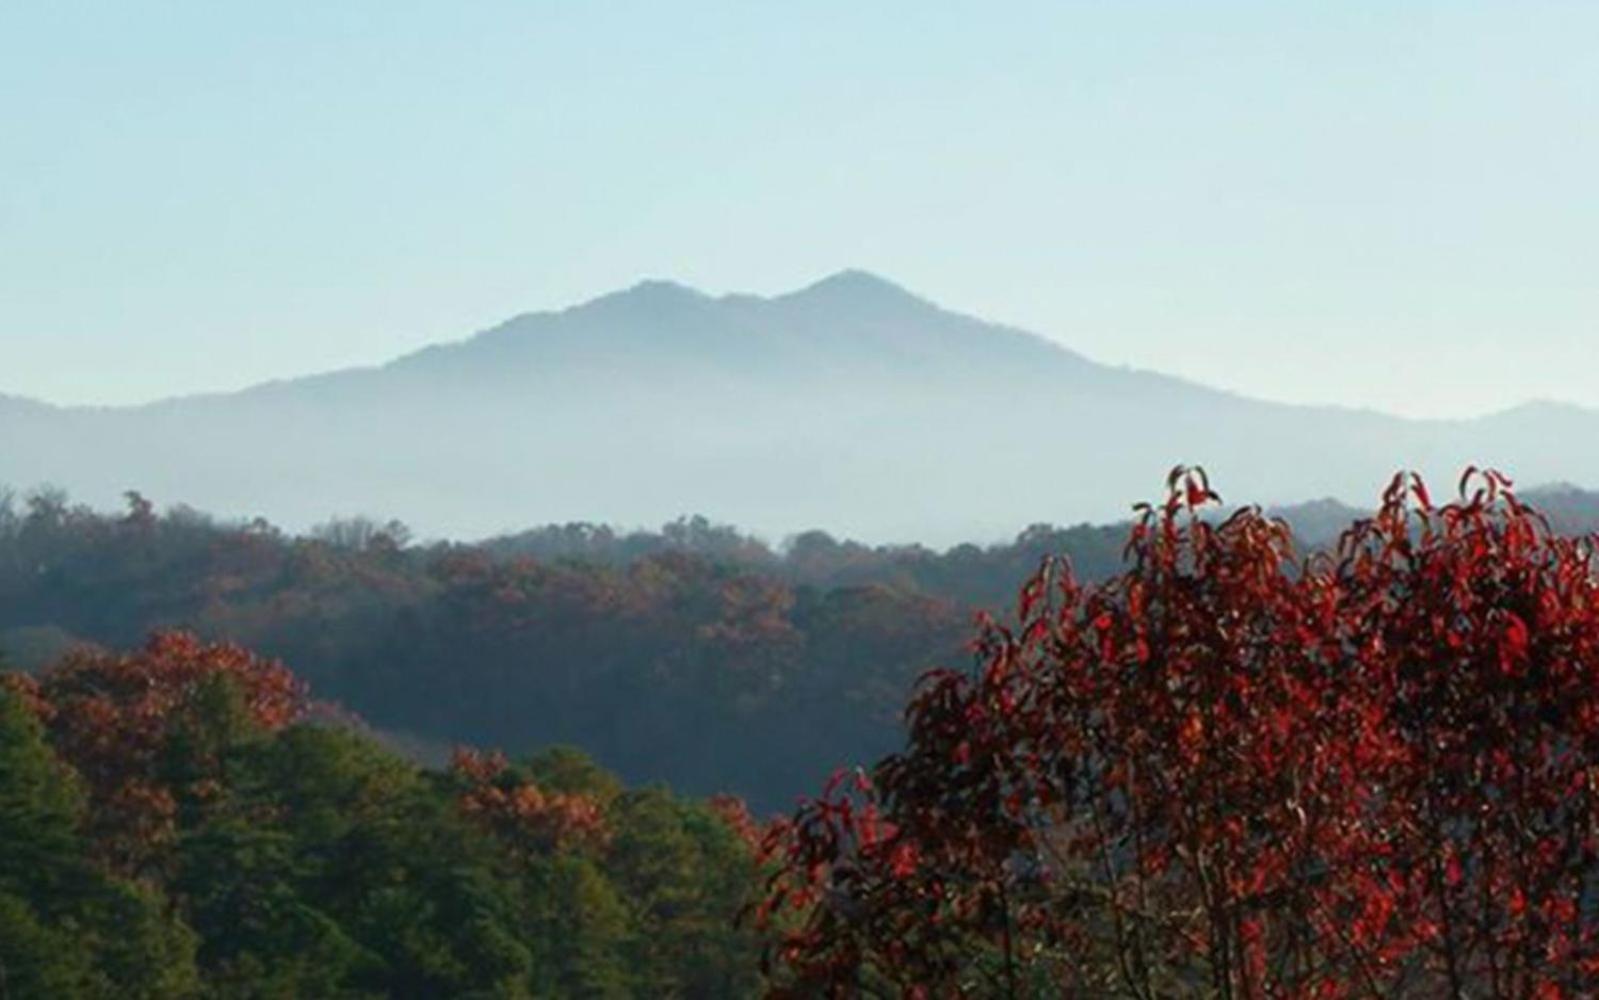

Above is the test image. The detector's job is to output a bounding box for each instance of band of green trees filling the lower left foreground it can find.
[0,659,758,1000]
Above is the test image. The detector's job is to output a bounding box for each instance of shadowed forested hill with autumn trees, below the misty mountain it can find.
[9,488,1599,810]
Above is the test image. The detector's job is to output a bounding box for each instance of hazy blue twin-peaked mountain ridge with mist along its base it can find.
[0,270,1599,544]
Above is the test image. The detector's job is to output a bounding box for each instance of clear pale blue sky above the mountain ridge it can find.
[0,0,1599,416]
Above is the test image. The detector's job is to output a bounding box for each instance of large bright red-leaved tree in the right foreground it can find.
[756,470,1599,998]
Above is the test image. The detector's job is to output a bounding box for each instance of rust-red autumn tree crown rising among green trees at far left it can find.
[27,632,305,869]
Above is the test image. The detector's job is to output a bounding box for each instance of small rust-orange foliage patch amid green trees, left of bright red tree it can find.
[449,747,611,858]
